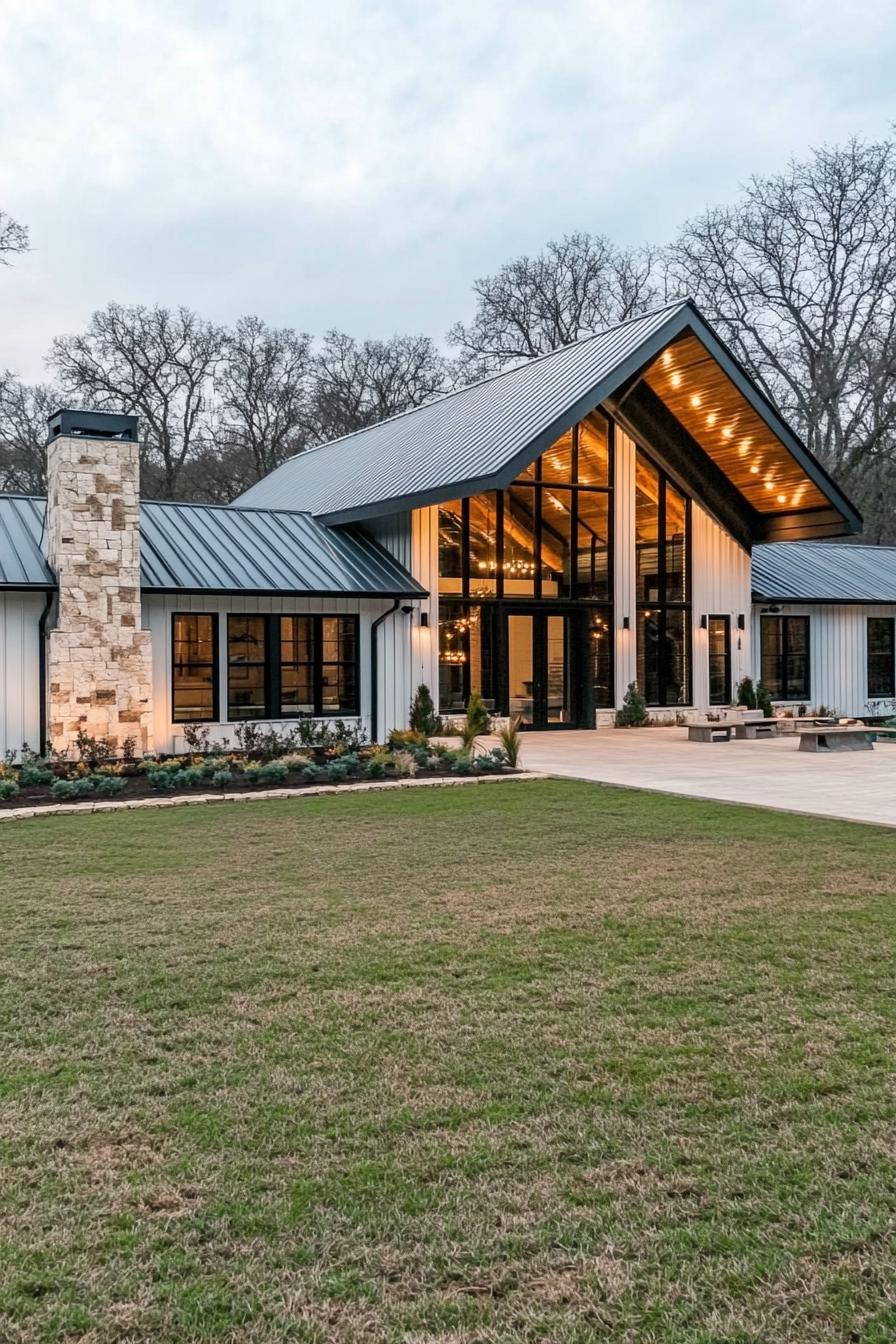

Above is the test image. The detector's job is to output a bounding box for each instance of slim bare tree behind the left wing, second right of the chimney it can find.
[215,317,313,488]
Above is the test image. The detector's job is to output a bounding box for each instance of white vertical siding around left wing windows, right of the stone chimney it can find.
[142,593,410,753]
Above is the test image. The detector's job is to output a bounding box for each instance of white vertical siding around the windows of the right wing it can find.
[752,602,896,719]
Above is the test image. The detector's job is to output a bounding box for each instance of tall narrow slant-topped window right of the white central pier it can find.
[635,452,692,706]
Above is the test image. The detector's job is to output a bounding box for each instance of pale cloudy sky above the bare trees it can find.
[0,0,896,379]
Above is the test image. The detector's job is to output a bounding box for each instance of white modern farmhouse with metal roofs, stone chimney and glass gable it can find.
[0,302,896,751]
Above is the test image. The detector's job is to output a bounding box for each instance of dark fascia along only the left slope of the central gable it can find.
[316,304,689,524]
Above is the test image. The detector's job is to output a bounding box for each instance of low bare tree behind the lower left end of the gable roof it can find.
[313,331,451,442]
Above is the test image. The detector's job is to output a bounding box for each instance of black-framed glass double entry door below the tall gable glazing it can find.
[506,612,574,728]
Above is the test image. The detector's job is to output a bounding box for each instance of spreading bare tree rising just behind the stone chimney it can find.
[48,304,224,499]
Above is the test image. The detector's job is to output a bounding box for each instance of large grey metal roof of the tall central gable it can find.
[235,300,861,530]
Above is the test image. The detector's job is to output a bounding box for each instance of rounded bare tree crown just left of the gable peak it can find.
[447,233,660,379]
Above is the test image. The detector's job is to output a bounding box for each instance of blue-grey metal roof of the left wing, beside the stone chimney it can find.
[0,495,426,598]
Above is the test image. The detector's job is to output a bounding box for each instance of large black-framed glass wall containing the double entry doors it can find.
[439,413,613,722]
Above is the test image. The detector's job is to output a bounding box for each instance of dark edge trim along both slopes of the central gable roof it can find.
[316,301,862,540]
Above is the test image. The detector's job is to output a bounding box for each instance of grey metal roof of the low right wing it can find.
[752,542,896,603]
